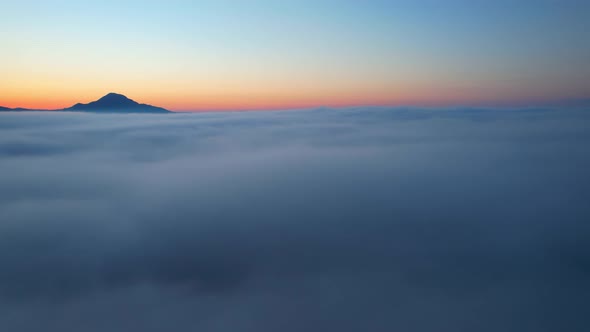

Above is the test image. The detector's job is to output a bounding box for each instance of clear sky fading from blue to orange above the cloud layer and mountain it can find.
[0,0,590,110]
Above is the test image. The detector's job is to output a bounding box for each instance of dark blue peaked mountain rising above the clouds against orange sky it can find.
[63,93,171,113]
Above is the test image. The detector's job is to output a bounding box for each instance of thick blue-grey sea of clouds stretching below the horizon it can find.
[0,109,590,332]
